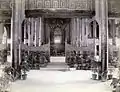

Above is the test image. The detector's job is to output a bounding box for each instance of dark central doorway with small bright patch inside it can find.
[46,18,70,56]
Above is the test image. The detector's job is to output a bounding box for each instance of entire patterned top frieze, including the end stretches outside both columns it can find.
[0,0,120,13]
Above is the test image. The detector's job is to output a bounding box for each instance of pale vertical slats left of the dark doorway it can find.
[24,17,42,46]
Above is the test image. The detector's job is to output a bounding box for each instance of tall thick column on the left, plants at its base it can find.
[11,0,24,69]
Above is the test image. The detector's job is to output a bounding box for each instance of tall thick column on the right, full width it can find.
[95,0,108,79]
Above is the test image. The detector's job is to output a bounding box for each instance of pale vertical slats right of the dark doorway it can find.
[71,17,90,47]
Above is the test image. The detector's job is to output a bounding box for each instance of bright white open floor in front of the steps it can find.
[11,70,111,92]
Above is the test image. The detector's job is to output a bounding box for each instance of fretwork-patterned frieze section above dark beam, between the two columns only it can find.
[26,0,92,10]
